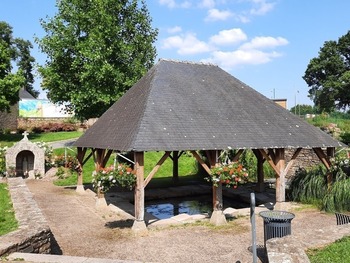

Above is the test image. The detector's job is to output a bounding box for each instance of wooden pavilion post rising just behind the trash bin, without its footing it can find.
[275,148,286,202]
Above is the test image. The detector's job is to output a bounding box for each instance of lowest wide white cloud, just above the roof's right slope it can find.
[203,50,281,70]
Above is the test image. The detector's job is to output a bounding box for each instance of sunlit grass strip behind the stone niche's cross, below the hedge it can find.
[0,131,83,147]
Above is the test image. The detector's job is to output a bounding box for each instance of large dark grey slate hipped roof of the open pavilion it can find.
[74,60,343,151]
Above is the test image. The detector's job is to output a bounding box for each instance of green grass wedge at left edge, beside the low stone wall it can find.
[0,183,18,236]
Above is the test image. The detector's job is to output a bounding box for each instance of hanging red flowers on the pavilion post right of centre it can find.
[205,162,248,188]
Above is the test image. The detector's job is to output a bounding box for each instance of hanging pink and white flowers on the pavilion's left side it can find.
[92,164,136,193]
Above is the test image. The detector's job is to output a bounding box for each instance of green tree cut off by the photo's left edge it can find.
[0,21,25,111]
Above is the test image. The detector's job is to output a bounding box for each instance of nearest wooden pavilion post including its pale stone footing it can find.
[132,152,148,235]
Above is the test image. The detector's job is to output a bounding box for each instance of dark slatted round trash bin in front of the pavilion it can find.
[259,210,295,246]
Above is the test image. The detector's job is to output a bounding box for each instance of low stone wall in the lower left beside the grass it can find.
[0,177,52,256]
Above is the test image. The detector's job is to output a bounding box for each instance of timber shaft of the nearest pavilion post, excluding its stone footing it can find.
[134,152,145,221]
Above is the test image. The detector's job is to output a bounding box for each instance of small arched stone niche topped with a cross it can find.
[5,132,45,178]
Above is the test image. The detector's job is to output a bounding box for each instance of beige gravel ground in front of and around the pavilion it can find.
[27,180,334,263]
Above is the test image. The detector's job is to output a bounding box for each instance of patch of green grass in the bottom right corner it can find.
[307,236,350,263]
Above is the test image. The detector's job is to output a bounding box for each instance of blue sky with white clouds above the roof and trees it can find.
[0,0,350,108]
